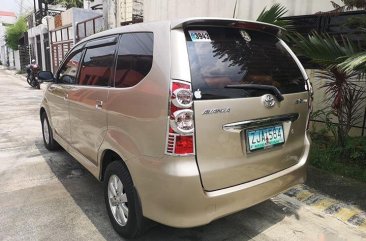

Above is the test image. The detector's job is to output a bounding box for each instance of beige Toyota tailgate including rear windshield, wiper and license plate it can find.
[185,26,308,190]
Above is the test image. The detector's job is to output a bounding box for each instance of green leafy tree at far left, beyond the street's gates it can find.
[5,17,28,50]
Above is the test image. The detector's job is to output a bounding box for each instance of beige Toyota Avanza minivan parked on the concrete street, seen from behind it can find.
[39,18,311,237]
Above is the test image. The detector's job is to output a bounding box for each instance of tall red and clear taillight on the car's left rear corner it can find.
[166,80,194,155]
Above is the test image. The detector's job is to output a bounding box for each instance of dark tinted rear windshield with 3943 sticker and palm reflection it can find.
[185,27,307,99]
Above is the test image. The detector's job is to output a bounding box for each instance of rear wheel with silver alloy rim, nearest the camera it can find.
[103,160,146,238]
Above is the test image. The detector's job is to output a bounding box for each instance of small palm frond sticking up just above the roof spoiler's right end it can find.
[257,3,292,29]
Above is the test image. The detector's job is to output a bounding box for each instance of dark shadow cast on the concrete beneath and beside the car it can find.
[36,142,299,241]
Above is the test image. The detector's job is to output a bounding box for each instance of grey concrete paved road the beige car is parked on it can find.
[0,70,366,241]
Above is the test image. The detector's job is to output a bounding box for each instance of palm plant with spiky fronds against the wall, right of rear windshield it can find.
[289,32,364,147]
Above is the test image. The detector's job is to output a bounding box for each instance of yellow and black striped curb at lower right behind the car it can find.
[284,184,366,232]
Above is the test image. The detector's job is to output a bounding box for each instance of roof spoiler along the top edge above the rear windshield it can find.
[171,18,286,36]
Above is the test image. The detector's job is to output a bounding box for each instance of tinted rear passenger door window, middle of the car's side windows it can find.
[79,45,115,86]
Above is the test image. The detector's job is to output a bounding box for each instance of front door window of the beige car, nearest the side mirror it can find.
[57,50,82,84]
